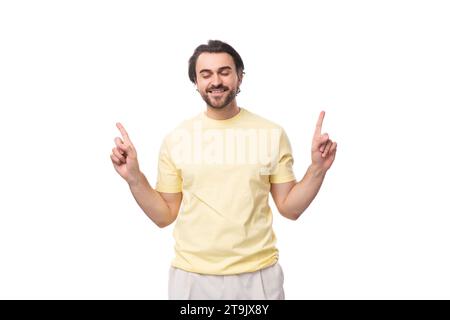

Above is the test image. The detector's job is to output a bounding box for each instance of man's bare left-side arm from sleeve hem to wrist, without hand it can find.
[129,173,183,228]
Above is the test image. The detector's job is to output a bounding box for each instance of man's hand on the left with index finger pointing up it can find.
[111,122,140,184]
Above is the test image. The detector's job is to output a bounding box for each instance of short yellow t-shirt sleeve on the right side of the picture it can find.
[269,130,295,183]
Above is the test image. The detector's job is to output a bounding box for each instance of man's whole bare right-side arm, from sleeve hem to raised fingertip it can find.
[270,111,337,220]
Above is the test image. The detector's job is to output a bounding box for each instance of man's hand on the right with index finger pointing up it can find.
[311,111,337,171]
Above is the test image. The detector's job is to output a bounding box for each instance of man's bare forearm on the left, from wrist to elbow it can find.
[129,173,172,227]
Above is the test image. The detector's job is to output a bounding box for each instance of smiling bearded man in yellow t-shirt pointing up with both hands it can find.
[111,40,337,299]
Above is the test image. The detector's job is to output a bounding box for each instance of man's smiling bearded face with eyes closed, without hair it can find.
[195,52,240,109]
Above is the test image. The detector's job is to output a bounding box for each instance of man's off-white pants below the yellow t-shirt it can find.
[169,262,284,300]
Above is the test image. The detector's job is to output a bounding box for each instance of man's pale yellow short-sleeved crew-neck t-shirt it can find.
[155,108,295,275]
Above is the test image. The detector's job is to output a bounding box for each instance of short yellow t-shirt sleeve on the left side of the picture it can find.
[155,139,182,193]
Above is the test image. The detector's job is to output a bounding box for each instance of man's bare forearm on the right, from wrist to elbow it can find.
[283,165,326,220]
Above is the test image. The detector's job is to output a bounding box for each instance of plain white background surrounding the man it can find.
[0,0,450,299]
